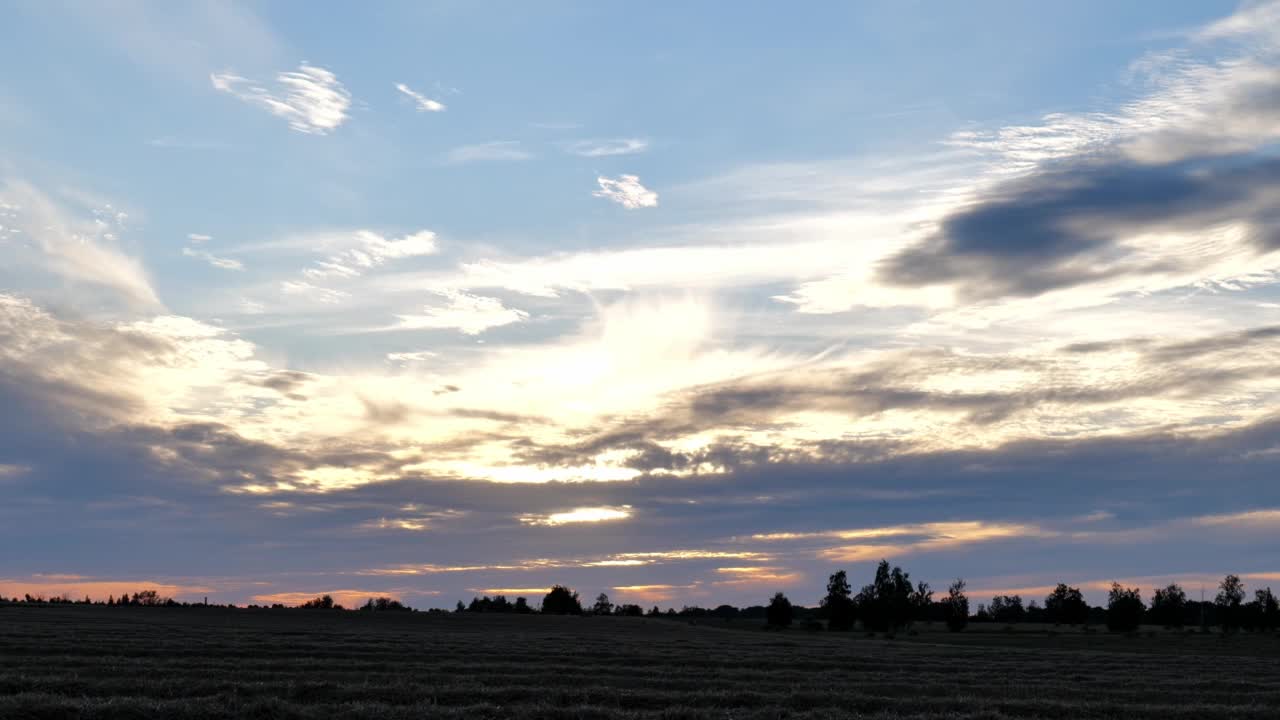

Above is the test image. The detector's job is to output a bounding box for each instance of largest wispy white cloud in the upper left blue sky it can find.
[209,63,351,135]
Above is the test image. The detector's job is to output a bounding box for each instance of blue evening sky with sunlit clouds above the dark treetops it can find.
[0,0,1280,607]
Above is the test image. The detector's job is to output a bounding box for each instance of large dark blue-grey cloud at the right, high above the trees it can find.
[879,156,1280,300]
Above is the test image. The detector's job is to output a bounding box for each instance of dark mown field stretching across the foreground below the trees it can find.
[0,606,1280,720]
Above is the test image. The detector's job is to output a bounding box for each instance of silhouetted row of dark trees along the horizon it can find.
[0,560,1280,634]
